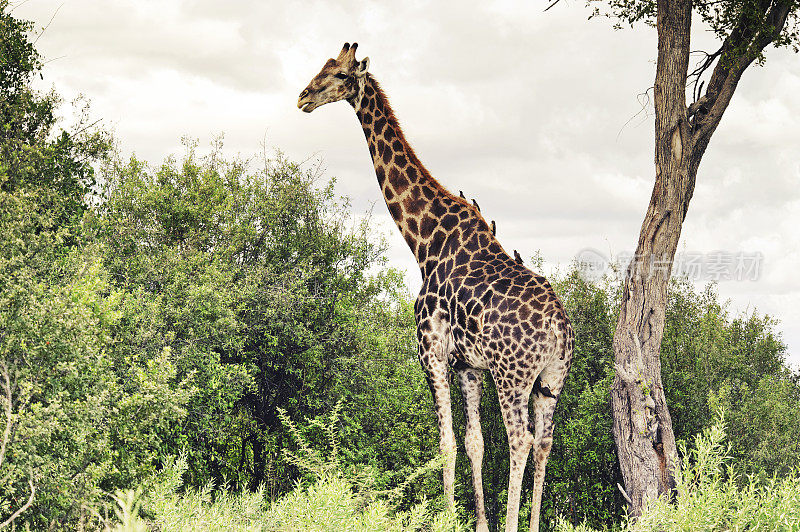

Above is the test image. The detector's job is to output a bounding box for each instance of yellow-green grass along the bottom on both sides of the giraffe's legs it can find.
[107,410,800,532]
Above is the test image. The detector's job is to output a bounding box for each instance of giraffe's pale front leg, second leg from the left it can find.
[458,369,489,532]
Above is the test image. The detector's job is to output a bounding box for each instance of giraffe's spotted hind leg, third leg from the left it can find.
[497,385,533,532]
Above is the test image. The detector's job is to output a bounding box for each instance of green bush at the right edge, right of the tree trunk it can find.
[661,282,800,476]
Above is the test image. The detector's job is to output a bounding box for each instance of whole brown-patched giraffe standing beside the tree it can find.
[297,43,574,532]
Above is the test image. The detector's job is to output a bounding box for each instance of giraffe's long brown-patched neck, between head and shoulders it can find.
[350,74,494,277]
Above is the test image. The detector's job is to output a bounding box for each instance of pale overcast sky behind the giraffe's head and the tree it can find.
[15,0,800,365]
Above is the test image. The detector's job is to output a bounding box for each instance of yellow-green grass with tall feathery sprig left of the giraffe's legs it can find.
[109,408,466,532]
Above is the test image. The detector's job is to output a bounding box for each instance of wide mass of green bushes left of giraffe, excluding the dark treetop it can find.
[0,122,436,526]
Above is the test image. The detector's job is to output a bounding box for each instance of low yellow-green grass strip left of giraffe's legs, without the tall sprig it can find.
[113,458,466,532]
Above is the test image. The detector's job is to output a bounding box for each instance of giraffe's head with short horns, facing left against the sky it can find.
[297,43,369,113]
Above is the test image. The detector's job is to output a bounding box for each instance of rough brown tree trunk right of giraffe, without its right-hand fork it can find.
[611,0,697,517]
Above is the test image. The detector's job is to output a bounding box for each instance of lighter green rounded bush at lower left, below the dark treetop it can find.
[0,206,192,526]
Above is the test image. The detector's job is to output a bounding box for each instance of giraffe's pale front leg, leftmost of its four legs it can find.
[420,344,456,512]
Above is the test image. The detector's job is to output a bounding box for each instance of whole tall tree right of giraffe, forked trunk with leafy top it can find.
[589,0,800,516]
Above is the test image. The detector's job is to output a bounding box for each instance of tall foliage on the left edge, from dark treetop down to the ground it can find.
[0,2,138,528]
